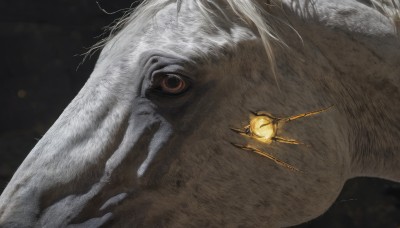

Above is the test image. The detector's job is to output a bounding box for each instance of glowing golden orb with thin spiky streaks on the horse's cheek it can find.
[231,106,332,172]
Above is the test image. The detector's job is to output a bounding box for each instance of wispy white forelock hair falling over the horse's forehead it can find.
[87,0,285,73]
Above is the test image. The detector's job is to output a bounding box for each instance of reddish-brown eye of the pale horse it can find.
[159,74,188,95]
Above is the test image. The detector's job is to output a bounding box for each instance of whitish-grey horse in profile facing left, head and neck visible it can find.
[0,0,400,227]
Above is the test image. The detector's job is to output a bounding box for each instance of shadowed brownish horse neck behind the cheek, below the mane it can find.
[310,31,400,181]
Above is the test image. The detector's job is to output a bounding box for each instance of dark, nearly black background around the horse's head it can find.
[0,0,400,228]
